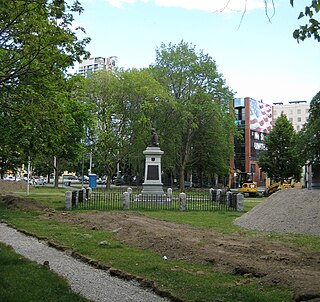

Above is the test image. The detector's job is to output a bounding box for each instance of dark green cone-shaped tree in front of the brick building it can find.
[258,114,304,181]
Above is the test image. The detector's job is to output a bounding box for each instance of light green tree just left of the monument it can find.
[82,69,170,187]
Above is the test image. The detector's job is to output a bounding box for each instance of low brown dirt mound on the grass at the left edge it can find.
[0,195,46,211]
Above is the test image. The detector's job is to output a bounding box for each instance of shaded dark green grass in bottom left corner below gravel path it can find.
[0,243,88,302]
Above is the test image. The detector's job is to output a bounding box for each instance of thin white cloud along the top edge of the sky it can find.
[105,0,265,12]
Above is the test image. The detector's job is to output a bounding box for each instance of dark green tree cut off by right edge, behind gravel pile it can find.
[299,91,320,164]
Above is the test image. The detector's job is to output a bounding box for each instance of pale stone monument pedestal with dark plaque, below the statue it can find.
[141,147,164,196]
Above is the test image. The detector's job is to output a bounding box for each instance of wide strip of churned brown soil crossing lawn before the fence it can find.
[0,184,320,302]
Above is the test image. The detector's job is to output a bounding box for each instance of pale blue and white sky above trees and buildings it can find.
[75,0,320,104]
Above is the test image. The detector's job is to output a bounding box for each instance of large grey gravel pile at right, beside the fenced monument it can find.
[235,189,320,235]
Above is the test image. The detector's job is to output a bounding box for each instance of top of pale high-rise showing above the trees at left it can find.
[78,56,118,78]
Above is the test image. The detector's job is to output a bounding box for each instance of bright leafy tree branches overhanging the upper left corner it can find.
[0,0,90,101]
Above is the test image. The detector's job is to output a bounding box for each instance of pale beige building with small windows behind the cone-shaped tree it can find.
[273,101,310,131]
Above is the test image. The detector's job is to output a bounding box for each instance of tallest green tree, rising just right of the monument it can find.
[152,41,233,188]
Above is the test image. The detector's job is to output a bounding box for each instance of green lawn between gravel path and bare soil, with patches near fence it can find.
[0,191,292,301]
